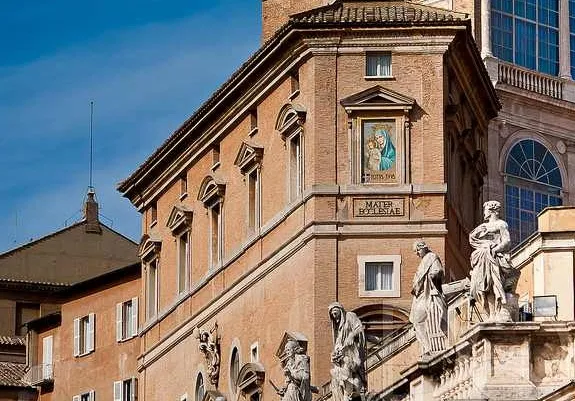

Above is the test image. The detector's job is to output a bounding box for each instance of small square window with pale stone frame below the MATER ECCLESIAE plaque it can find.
[357,255,401,297]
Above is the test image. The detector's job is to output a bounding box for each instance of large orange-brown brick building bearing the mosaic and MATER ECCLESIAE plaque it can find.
[119,0,499,401]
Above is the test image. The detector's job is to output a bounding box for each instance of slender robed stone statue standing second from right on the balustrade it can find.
[409,241,447,355]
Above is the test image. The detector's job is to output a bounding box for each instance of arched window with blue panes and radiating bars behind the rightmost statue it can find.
[505,139,563,245]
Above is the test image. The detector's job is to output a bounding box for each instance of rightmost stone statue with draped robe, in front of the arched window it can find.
[469,201,519,322]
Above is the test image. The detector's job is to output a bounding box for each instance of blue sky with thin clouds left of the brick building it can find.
[0,0,261,252]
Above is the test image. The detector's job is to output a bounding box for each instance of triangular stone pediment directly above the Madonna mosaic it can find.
[341,85,415,113]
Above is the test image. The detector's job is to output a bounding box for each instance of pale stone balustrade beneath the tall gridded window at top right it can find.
[497,60,564,99]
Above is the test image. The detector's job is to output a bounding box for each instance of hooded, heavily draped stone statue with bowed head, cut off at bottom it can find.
[329,302,366,401]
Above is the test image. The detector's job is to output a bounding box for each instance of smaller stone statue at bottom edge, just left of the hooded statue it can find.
[277,340,311,401]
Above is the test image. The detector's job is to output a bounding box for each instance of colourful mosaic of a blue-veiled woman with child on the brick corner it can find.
[361,120,397,183]
